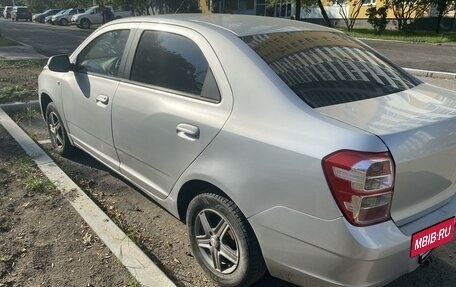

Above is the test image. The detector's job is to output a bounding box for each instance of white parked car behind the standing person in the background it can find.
[71,6,133,29]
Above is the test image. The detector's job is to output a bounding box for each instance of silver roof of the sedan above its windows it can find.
[116,14,335,37]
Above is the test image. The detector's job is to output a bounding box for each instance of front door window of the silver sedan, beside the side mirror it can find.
[77,30,130,77]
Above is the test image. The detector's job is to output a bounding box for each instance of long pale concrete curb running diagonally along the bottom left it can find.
[0,105,176,287]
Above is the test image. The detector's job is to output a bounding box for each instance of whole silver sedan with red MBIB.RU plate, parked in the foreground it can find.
[39,14,456,286]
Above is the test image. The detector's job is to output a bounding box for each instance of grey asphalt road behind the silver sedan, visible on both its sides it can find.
[0,18,456,73]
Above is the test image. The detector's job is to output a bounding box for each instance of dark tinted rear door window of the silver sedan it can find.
[130,31,220,101]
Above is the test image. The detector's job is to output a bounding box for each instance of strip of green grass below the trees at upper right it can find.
[342,29,456,43]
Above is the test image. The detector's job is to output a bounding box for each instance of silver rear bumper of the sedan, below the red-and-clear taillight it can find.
[249,207,418,286]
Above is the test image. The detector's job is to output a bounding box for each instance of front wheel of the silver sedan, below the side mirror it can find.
[46,102,75,156]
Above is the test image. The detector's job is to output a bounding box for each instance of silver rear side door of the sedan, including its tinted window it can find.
[112,24,232,198]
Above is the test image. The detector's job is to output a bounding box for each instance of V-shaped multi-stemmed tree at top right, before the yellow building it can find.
[386,0,433,31]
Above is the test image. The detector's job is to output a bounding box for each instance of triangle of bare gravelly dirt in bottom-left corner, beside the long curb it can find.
[0,126,137,287]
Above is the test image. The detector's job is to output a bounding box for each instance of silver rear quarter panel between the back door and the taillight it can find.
[167,32,387,219]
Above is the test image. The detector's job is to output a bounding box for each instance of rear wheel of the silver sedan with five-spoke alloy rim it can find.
[187,193,266,287]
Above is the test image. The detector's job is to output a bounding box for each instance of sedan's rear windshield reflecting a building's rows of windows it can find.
[242,31,419,108]
